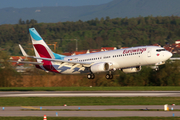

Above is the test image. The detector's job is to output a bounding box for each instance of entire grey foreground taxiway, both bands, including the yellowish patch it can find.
[0,105,180,117]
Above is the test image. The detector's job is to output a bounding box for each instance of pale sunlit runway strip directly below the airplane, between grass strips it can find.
[0,91,180,97]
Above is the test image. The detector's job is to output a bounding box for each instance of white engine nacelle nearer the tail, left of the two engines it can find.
[90,62,110,73]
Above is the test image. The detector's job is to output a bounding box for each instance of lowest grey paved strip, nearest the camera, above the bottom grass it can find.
[0,111,180,117]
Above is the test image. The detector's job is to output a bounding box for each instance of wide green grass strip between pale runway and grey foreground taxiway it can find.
[0,97,180,106]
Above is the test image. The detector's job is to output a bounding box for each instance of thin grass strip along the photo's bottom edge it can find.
[0,116,180,120]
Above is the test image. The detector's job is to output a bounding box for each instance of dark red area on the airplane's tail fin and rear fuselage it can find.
[34,44,59,73]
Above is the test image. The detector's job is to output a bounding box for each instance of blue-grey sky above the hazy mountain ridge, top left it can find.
[0,0,113,9]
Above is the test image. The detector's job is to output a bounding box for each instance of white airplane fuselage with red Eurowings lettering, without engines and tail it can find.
[53,46,172,74]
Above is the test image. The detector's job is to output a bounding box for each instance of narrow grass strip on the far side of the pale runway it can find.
[0,86,180,91]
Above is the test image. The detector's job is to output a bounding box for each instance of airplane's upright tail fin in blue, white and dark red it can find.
[29,28,65,59]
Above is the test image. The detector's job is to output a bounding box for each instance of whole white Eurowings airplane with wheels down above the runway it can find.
[17,28,172,79]
